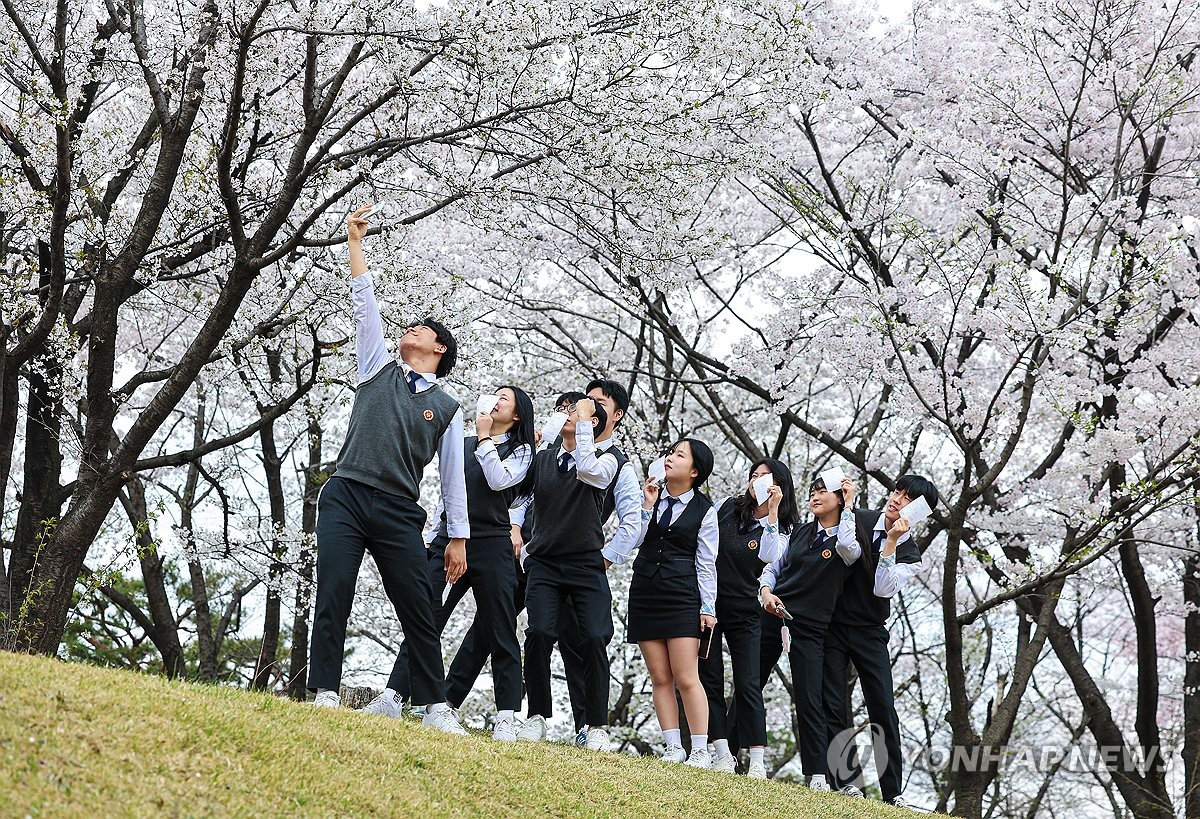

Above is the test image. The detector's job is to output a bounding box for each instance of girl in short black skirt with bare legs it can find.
[626,438,719,767]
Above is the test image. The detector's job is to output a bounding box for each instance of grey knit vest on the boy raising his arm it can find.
[336,361,458,501]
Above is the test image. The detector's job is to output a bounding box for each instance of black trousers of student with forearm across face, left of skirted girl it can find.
[524,550,613,725]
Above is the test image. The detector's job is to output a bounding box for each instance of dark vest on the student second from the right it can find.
[772,520,857,628]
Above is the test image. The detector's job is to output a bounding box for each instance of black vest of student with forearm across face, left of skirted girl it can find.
[528,448,610,557]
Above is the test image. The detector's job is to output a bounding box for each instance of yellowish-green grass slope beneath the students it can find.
[0,652,916,819]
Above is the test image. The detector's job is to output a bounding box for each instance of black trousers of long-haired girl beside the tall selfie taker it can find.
[388,536,522,711]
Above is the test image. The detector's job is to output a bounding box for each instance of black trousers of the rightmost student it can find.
[822,623,904,801]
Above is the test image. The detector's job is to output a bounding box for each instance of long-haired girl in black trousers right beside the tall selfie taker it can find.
[364,384,534,742]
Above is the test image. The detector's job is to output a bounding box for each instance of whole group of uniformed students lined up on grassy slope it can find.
[308,209,937,805]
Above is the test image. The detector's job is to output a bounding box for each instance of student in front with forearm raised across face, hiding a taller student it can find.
[517,397,617,751]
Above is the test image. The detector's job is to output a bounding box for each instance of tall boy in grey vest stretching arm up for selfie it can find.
[308,208,470,734]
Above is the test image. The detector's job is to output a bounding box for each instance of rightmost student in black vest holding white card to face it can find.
[823,474,937,807]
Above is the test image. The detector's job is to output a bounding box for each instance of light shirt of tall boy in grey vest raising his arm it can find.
[350,271,470,538]
